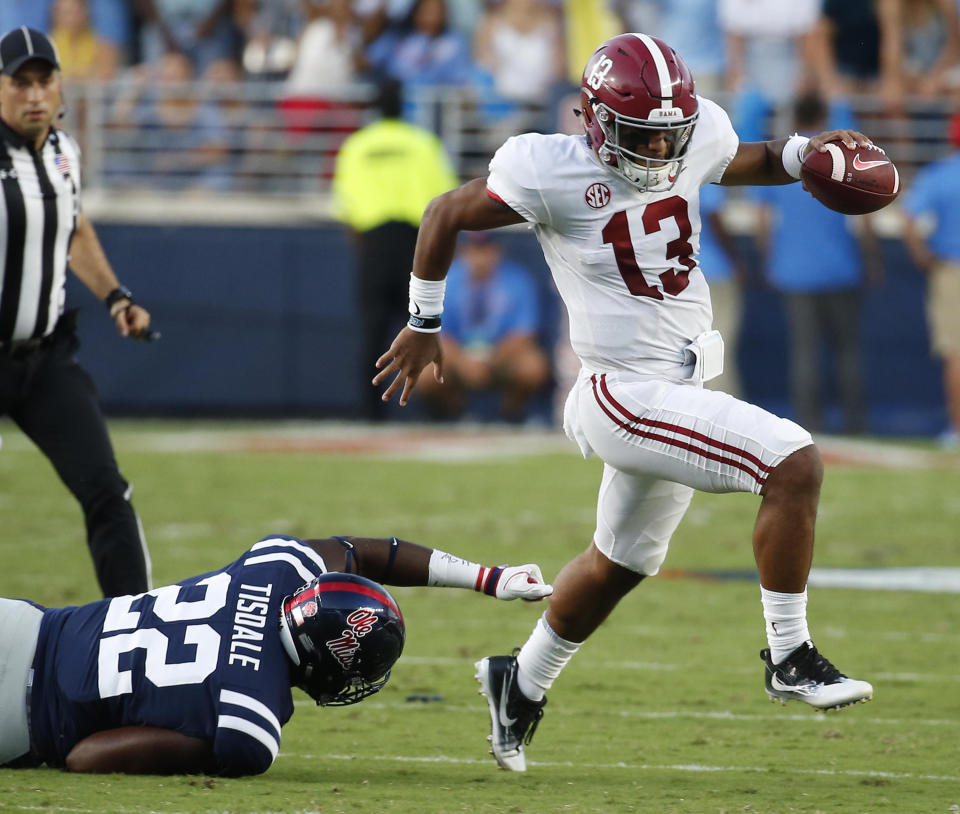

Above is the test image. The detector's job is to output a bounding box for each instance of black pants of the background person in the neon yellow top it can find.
[358,221,417,421]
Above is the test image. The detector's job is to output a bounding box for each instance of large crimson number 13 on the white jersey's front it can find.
[601,195,697,300]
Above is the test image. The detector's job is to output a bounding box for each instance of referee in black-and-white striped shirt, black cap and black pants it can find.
[0,26,150,596]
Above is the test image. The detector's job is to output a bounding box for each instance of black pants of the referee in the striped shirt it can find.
[0,313,150,596]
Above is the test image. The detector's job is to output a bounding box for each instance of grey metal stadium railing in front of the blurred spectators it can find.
[64,79,952,231]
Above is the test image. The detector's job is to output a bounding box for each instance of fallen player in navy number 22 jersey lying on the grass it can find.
[0,536,552,776]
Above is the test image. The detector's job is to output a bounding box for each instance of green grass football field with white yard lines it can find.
[0,422,960,814]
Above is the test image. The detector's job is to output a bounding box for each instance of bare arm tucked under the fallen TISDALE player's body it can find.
[67,726,216,774]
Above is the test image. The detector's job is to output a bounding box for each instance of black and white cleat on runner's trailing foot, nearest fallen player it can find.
[475,656,547,772]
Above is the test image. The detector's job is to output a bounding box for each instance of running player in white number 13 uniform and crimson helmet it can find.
[373,34,873,771]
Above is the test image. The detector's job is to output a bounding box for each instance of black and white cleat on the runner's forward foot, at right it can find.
[760,641,873,710]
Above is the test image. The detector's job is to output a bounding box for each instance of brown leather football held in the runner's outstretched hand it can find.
[800,141,900,215]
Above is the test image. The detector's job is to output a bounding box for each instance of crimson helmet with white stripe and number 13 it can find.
[580,34,697,191]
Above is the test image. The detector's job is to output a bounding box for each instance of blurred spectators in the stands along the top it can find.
[0,0,960,190]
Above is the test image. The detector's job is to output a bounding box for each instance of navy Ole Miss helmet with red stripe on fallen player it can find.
[280,572,406,706]
